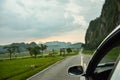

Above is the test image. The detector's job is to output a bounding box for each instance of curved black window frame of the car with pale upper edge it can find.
[86,26,120,76]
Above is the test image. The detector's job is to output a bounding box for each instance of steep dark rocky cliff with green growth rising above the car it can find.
[85,0,120,49]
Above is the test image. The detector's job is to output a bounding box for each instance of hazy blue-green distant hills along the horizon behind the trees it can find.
[0,41,82,54]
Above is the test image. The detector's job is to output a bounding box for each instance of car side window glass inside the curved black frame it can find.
[94,46,120,80]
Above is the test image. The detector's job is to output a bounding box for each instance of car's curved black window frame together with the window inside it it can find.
[85,26,120,80]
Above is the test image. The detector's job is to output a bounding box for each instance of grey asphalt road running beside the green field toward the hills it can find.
[27,53,89,80]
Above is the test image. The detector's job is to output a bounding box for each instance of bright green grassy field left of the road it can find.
[0,51,78,80]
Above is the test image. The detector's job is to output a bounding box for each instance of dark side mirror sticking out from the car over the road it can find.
[68,65,83,75]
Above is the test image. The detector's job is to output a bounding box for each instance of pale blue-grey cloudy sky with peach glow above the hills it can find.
[0,0,104,45]
